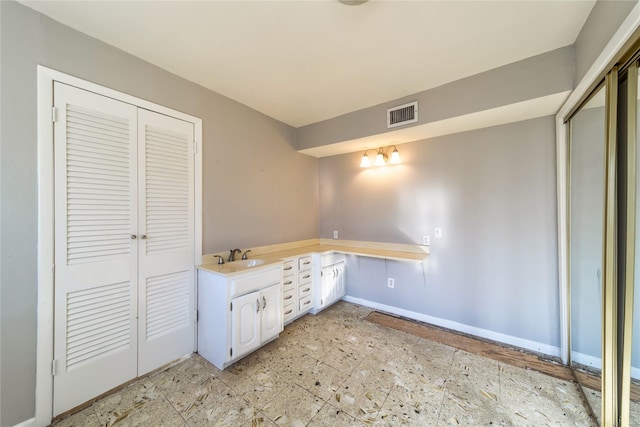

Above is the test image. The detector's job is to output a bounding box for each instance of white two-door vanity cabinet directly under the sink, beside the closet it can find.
[198,264,283,369]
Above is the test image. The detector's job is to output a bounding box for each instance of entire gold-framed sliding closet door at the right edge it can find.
[567,56,640,426]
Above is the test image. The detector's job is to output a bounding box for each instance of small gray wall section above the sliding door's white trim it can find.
[575,0,637,84]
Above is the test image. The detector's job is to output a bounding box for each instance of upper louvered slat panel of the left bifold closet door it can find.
[66,105,132,265]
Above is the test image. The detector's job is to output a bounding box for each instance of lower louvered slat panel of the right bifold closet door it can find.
[146,271,190,341]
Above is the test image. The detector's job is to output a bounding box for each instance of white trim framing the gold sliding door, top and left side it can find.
[556,3,640,363]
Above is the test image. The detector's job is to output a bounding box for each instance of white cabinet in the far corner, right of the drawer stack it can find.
[311,254,346,314]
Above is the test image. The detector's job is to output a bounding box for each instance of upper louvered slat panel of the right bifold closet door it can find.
[145,126,191,254]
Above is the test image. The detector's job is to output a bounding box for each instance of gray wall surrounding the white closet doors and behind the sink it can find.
[0,1,318,426]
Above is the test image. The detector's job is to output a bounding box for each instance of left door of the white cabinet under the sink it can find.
[231,291,262,359]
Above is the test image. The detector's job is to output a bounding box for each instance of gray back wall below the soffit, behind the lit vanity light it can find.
[320,117,560,347]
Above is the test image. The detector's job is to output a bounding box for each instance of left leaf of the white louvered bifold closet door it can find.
[53,83,138,415]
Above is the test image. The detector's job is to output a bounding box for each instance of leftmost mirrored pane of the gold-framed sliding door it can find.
[568,81,606,424]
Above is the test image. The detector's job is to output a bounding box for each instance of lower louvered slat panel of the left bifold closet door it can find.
[66,282,131,369]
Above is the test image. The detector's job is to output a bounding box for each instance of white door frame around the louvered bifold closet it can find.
[35,65,202,426]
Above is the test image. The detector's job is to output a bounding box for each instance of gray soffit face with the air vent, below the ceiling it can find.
[297,46,574,150]
